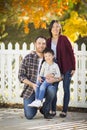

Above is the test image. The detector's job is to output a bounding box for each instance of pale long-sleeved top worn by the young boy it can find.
[40,61,60,77]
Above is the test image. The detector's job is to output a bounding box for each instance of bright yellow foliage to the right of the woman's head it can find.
[63,11,87,42]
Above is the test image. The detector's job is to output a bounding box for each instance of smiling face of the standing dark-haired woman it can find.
[51,22,61,36]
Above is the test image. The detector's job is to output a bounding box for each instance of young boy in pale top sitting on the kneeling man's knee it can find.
[28,49,61,108]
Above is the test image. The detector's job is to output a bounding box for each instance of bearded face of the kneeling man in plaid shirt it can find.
[35,38,46,53]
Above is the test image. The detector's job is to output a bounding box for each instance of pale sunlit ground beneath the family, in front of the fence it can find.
[0,108,87,130]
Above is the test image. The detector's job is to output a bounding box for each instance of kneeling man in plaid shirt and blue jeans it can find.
[18,36,56,119]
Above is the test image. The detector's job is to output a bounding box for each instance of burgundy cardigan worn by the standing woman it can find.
[47,35,75,74]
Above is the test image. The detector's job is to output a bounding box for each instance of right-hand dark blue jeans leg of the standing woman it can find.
[62,71,71,112]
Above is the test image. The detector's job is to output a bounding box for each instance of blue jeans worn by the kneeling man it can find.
[24,85,56,119]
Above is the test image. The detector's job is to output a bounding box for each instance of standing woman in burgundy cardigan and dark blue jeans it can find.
[47,20,75,117]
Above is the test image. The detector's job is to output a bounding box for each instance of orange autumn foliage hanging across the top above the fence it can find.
[0,0,79,33]
